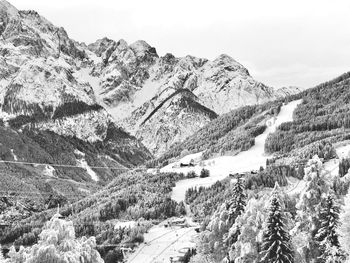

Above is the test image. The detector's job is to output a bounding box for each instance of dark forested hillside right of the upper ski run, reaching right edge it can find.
[265,73,350,158]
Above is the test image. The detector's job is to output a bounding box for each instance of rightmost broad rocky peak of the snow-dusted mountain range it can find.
[194,55,276,114]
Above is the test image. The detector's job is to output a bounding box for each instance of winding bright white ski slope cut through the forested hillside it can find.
[161,100,301,202]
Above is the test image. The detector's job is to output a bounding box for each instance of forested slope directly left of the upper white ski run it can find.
[152,100,283,166]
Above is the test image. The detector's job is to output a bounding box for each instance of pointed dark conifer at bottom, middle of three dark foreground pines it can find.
[260,189,294,263]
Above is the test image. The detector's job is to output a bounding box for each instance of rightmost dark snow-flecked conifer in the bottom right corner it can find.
[315,195,344,263]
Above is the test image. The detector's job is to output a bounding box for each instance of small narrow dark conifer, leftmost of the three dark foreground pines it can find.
[228,178,247,225]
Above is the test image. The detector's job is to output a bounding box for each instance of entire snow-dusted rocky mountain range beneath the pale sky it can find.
[0,0,299,162]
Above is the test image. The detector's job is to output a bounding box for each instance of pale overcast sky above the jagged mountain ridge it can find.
[9,0,350,87]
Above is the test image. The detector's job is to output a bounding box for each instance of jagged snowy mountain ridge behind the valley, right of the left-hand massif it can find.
[88,38,300,155]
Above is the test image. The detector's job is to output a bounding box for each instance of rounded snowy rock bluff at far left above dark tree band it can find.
[1,57,96,117]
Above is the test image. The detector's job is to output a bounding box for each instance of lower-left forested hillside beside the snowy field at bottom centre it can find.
[0,171,185,258]
